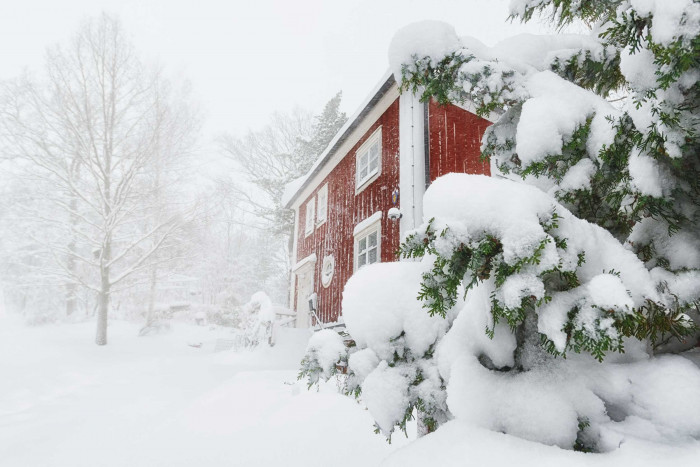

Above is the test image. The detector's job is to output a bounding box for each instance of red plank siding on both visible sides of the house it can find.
[292,95,491,328]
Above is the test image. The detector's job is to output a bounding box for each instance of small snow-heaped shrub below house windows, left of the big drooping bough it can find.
[300,262,451,437]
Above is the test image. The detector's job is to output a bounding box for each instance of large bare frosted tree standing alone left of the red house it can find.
[0,14,196,345]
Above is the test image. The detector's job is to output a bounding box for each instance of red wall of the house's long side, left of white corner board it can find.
[295,99,399,322]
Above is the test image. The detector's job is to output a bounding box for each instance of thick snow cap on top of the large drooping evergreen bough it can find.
[424,174,658,306]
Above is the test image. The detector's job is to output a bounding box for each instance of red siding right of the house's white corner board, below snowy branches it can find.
[428,100,491,182]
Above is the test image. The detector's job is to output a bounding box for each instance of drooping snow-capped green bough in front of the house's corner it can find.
[402,174,694,368]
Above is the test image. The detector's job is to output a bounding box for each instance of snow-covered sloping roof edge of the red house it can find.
[282,70,396,208]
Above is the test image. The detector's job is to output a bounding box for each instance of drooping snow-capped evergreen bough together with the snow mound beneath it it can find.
[402,174,700,450]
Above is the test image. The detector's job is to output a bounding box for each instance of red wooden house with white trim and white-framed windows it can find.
[286,74,491,327]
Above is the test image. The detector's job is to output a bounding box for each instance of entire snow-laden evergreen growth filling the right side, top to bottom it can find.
[300,0,700,451]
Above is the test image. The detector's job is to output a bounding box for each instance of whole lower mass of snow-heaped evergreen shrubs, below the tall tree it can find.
[304,174,700,451]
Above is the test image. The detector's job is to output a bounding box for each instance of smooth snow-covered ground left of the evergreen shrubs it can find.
[0,316,407,467]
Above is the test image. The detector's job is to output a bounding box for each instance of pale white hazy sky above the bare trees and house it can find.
[0,0,548,137]
